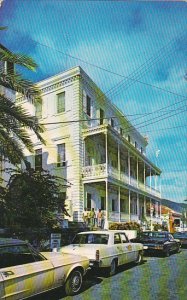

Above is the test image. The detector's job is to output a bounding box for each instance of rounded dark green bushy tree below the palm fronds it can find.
[5,168,68,228]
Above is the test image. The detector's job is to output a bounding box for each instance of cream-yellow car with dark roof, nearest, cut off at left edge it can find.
[0,238,89,300]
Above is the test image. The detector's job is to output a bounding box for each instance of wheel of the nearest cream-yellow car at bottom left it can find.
[65,270,82,296]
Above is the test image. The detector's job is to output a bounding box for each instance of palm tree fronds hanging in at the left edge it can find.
[0,39,45,164]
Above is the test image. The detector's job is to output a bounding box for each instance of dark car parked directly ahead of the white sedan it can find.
[131,231,181,256]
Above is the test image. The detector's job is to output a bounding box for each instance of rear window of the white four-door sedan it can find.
[72,233,109,245]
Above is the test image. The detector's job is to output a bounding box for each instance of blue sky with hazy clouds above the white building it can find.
[0,0,187,202]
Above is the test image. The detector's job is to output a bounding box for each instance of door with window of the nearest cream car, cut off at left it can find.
[0,244,54,300]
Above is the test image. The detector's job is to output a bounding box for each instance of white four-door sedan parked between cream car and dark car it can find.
[60,230,143,275]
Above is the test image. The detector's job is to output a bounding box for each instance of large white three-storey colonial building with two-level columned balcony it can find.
[16,67,161,222]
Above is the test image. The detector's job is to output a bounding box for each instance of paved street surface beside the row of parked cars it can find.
[34,249,187,300]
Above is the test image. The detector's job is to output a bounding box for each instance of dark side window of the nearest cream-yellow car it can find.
[0,244,45,268]
